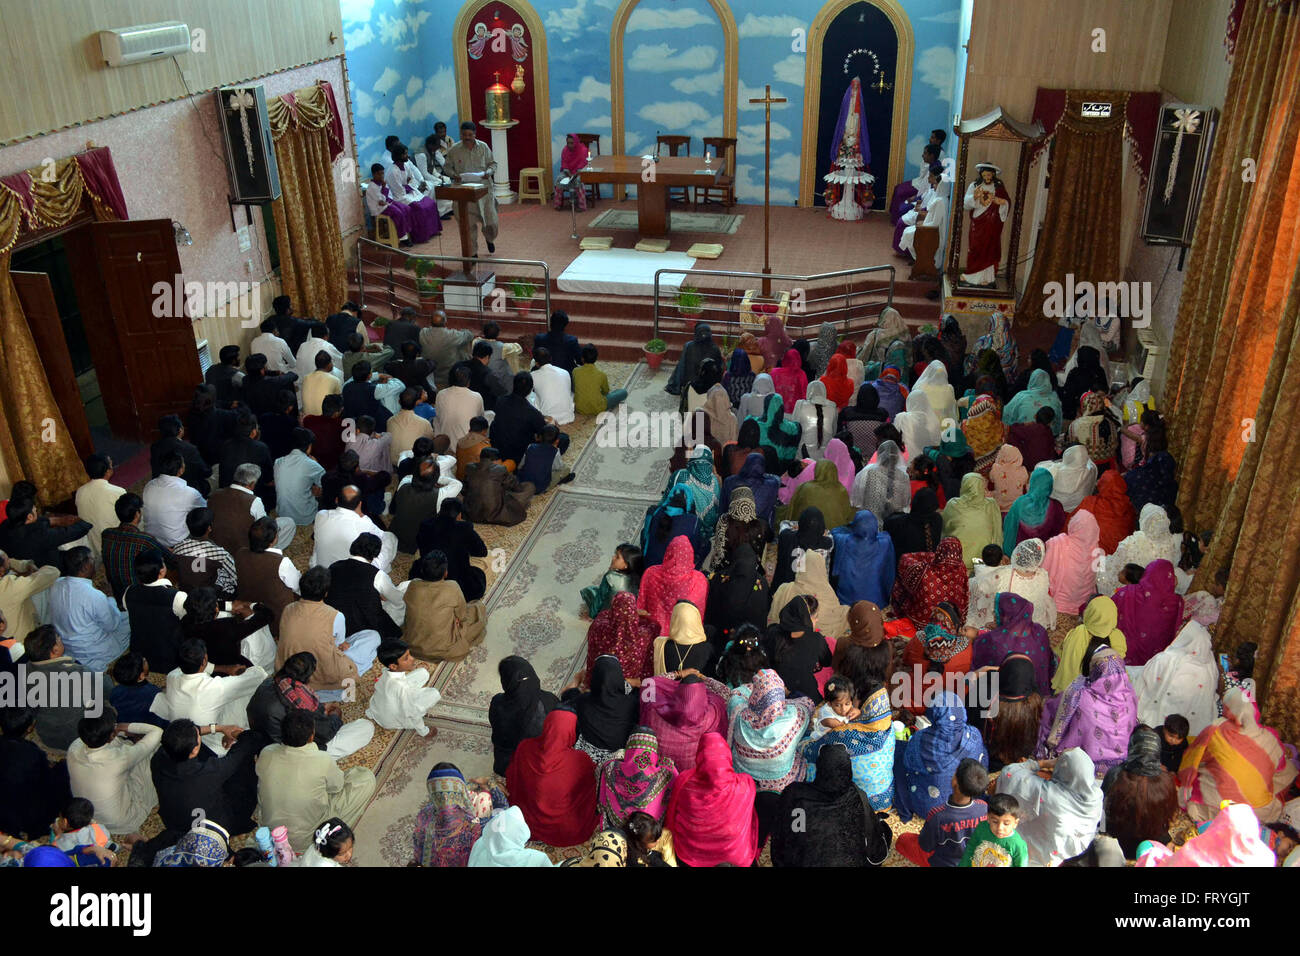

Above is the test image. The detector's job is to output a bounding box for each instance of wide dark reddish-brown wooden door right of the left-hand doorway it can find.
[66,219,203,441]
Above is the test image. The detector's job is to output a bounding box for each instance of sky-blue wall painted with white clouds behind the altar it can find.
[339,0,962,203]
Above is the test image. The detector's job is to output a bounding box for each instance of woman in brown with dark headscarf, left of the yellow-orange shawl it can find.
[1101,711,1182,860]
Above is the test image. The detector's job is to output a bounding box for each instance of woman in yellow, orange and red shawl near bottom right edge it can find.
[1178,688,1296,823]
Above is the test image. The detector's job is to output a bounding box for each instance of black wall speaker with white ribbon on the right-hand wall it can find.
[1141,103,1218,246]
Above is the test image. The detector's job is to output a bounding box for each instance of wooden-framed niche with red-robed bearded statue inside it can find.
[944,107,1045,327]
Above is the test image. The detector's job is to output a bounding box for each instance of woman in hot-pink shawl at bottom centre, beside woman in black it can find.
[663,734,759,866]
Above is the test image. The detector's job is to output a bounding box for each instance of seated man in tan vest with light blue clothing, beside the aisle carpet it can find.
[276,567,380,701]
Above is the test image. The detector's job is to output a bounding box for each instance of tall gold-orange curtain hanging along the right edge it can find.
[1165,3,1300,739]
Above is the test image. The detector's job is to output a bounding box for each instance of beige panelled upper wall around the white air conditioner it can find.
[0,0,343,144]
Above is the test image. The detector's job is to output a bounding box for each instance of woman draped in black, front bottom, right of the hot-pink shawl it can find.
[772,741,892,866]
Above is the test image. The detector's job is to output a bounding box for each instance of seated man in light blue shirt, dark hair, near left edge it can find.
[48,548,131,671]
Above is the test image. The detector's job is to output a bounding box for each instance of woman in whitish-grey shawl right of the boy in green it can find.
[997,749,1101,866]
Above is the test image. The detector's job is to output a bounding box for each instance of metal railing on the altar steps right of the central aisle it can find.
[654,265,894,341]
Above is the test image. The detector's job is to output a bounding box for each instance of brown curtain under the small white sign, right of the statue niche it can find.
[1015,90,1128,323]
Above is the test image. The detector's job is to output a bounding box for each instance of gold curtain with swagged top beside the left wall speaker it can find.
[267,86,347,317]
